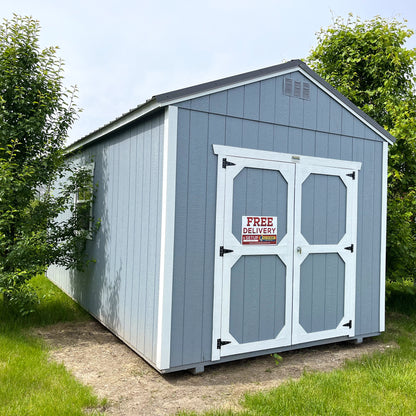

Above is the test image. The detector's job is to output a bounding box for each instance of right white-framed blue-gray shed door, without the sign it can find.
[292,165,357,344]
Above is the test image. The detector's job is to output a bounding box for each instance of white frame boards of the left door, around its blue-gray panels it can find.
[216,155,295,357]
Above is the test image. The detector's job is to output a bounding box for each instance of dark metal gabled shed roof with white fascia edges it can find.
[67,59,396,153]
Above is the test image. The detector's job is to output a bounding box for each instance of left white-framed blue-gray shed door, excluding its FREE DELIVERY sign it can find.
[221,157,294,356]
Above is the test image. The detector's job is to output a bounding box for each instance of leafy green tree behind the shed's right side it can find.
[307,15,416,280]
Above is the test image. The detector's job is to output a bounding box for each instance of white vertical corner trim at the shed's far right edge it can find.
[380,142,388,332]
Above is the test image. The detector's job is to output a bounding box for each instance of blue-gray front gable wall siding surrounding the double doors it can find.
[171,72,382,367]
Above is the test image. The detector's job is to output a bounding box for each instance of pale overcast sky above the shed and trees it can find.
[0,0,416,144]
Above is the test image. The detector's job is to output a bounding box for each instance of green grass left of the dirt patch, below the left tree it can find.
[0,276,105,416]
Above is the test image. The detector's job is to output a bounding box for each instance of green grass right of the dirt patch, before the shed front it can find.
[178,297,416,416]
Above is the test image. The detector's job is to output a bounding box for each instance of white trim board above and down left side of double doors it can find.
[211,144,361,361]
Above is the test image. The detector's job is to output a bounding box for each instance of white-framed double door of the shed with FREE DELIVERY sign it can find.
[212,145,360,360]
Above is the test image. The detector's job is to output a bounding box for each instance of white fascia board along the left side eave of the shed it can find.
[65,102,164,154]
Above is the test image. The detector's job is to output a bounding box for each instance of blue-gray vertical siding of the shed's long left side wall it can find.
[48,115,164,362]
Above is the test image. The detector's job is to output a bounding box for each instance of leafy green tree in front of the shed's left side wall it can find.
[0,15,95,313]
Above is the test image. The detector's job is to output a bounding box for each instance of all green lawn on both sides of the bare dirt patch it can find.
[0,277,416,416]
